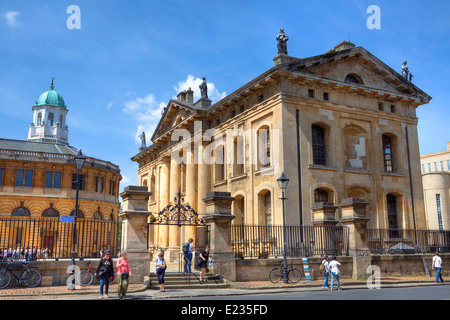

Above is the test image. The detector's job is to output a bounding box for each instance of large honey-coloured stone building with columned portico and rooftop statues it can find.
[132,37,431,260]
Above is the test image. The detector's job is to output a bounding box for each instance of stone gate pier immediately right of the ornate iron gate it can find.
[203,192,236,281]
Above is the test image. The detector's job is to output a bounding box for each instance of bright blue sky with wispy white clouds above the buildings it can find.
[0,0,450,190]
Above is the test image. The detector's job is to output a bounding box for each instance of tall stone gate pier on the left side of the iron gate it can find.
[119,186,151,283]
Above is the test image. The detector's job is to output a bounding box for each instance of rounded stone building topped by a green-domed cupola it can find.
[0,82,122,256]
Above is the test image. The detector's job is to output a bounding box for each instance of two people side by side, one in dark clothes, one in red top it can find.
[95,250,131,299]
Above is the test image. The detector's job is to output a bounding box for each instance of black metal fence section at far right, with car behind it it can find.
[367,229,450,254]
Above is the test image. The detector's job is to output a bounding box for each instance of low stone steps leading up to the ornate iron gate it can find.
[149,271,230,290]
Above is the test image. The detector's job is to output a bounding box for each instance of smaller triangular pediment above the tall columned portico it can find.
[151,100,201,141]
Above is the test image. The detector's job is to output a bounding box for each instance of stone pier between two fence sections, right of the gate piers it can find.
[339,198,372,279]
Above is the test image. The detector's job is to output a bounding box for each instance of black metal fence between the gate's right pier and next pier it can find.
[231,224,349,259]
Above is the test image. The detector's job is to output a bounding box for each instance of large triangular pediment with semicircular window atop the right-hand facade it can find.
[285,47,431,102]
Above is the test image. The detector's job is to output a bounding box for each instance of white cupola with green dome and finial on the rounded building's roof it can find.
[28,78,69,145]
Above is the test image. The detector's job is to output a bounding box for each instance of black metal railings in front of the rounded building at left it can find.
[0,217,119,260]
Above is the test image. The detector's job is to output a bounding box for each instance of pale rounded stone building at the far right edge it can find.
[420,142,450,231]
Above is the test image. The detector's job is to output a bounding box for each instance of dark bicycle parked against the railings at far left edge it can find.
[0,262,42,289]
